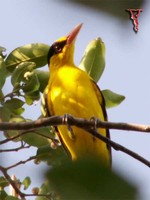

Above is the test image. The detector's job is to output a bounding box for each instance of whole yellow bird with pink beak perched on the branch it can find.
[43,24,111,165]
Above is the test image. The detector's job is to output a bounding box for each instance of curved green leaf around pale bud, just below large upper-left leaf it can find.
[11,62,35,87]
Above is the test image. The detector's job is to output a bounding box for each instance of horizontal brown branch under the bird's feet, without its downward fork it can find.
[0,115,150,132]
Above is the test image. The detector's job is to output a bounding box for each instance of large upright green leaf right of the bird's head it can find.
[79,38,105,82]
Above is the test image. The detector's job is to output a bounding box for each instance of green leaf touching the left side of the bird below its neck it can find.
[34,70,49,93]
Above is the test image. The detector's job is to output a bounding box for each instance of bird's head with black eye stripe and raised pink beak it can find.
[48,24,82,67]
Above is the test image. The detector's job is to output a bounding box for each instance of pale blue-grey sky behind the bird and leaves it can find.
[0,0,150,200]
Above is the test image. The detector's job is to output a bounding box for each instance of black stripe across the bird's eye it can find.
[47,40,67,64]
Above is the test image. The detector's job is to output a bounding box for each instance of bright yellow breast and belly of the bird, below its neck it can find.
[47,66,109,163]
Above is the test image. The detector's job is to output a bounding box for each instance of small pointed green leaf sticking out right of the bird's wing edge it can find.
[102,90,125,108]
